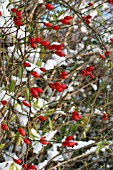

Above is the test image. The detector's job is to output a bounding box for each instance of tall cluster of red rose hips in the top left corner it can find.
[11,8,23,27]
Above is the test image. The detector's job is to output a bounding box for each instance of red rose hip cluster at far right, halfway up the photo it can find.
[81,66,94,79]
